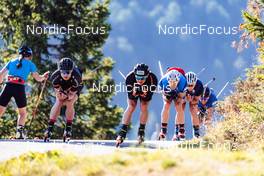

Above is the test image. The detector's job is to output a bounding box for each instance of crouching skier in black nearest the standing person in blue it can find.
[44,58,83,142]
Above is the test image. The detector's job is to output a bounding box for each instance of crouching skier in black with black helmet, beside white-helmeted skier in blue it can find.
[116,64,158,146]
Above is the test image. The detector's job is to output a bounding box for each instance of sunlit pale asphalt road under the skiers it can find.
[0,139,182,161]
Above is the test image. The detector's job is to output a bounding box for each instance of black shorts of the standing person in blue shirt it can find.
[0,83,27,108]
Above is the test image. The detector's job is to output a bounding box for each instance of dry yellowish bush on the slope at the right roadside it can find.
[206,63,264,150]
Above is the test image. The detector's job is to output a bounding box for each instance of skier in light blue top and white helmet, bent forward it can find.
[159,70,186,140]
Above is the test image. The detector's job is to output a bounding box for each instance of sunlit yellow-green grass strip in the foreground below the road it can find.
[0,148,264,176]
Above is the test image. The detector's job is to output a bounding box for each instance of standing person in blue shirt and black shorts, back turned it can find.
[0,45,49,139]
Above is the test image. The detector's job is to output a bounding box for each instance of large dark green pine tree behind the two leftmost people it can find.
[0,0,122,139]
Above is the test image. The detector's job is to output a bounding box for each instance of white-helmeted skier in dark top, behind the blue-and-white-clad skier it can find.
[183,71,204,138]
